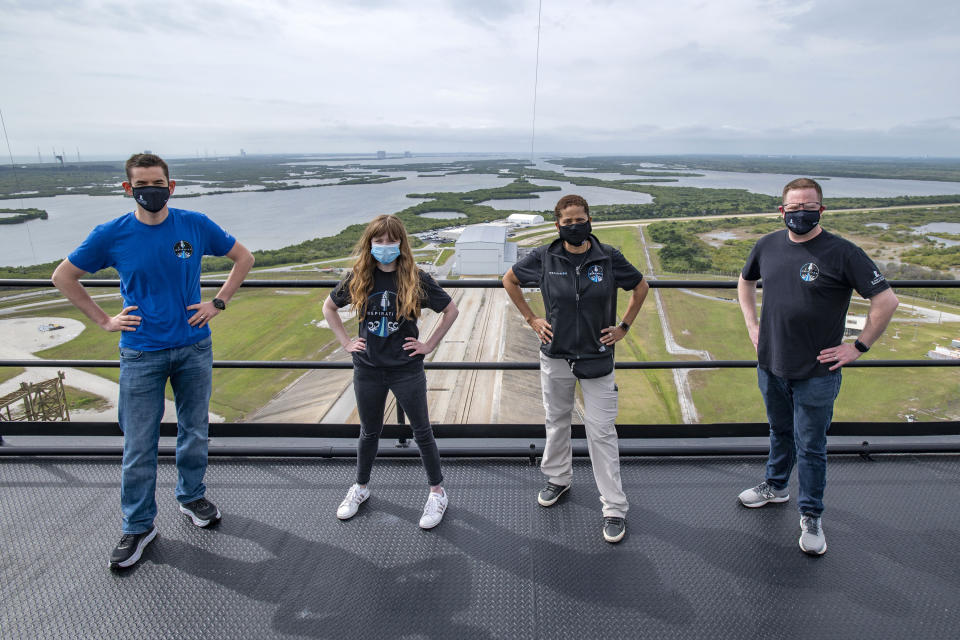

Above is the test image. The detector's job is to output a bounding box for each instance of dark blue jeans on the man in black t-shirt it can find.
[757,368,841,516]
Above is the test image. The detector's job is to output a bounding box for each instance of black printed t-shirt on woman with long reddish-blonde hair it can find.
[330,269,450,367]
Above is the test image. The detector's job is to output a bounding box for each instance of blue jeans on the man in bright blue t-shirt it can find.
[119,337,213,533]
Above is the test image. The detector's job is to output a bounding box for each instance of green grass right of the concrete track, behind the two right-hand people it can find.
[597,228,960,422]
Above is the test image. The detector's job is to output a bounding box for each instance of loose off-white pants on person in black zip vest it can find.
[540,352,629,518]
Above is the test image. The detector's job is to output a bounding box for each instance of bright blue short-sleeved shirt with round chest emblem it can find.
[68,209,236,351]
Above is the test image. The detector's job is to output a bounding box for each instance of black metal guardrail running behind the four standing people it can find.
[0,279,960,459]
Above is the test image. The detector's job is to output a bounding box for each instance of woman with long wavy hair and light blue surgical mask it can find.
[323,215,459,529]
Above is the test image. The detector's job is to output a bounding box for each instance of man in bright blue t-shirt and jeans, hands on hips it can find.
[53,153,253,569]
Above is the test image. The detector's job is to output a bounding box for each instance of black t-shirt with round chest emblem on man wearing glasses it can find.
[741,229,890,380]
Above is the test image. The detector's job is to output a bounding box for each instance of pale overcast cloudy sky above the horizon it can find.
[0,0,960,160]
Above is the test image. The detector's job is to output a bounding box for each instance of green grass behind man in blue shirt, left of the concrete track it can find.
[24,289,337,420]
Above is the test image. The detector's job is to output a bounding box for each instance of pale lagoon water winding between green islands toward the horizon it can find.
[0,155,960,266]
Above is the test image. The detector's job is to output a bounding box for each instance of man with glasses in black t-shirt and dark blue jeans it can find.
[737,178,899,555]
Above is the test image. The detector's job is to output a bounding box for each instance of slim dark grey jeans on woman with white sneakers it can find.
[353,363,443,486]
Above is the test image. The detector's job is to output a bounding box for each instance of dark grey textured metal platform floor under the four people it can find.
[0,455,960,640]
